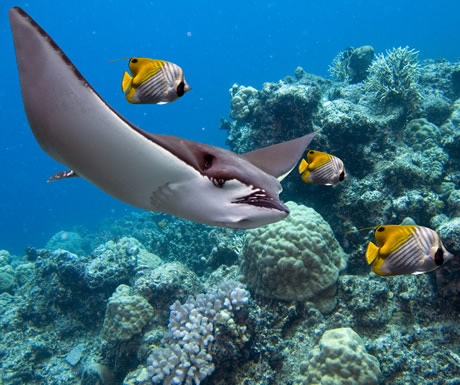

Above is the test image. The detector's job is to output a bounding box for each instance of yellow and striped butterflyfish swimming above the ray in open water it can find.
[121,57,192,104]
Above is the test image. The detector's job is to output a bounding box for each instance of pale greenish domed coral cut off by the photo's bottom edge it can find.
[302,328,381,385]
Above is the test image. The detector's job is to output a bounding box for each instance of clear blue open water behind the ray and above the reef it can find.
[0,0,460,255]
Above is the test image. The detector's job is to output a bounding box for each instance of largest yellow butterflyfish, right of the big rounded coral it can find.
[366,225,453,276]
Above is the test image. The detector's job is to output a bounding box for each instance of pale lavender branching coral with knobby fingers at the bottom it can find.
[147,281,249,385]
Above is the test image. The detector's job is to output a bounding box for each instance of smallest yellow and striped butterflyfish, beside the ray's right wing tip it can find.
[299,150,347,186]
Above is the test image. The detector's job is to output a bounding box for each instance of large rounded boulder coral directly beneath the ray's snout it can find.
[240,202,346,301]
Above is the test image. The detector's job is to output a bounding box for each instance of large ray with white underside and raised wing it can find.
[9,7,315,229]
